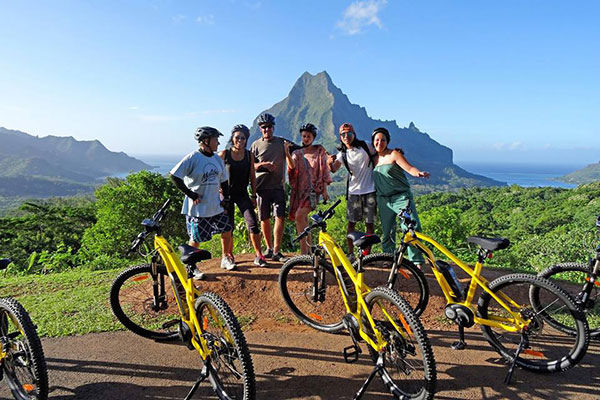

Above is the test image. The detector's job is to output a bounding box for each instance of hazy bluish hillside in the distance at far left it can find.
[0,127,151,197]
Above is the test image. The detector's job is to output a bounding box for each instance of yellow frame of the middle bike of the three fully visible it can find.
[319,231,411,352]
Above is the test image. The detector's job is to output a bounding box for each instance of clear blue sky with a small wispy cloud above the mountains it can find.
[0,0,600,165]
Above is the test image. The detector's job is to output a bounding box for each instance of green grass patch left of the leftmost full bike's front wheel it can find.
[0,270,124,337]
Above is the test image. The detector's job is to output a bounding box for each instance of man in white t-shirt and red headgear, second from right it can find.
[328,123,377,256]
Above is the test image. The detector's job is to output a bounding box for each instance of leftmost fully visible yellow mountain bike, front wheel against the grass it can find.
[110,200,256,400]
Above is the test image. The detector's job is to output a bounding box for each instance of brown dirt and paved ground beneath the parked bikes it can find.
[0,256,600,400]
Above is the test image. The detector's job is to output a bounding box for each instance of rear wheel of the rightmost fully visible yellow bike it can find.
[478,274,589,373]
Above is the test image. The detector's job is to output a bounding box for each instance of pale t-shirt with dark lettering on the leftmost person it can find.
[170,151,229,217]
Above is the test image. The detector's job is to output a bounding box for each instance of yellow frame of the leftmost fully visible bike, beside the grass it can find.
[152,234,232,360]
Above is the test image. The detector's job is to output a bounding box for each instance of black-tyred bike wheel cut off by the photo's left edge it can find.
[0,297,48,400]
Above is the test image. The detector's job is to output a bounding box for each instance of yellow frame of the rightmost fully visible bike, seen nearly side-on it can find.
[392,230,529,332]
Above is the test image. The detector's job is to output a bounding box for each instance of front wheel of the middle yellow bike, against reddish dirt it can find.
[279,255,356,333]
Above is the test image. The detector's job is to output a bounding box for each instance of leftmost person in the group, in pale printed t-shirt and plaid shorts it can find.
[169,126,235,279]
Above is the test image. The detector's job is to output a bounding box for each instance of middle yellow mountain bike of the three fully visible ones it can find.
[279,200,436,399]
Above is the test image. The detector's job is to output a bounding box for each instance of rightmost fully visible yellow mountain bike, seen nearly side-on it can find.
[363,205,589,383]
